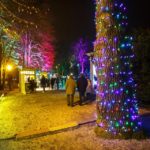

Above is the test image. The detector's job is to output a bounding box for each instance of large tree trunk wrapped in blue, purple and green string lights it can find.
[94,0,141,135]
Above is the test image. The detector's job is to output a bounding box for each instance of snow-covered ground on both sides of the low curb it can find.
[0,91,150,150]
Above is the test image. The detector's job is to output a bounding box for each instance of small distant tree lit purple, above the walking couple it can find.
[73,38,89,73]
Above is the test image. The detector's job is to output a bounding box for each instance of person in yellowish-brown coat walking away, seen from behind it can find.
[66,75,76,107]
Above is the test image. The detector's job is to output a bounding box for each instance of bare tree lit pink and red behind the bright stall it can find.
[18,33,54,71]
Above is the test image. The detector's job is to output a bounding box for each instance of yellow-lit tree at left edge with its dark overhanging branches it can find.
[0,0,38,86]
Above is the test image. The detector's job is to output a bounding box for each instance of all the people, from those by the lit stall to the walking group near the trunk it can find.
[28,74,96,107]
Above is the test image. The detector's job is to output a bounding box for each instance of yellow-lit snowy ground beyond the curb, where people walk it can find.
[0,91,96,139]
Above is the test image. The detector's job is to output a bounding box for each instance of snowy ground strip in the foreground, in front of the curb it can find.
[0,126,150,150]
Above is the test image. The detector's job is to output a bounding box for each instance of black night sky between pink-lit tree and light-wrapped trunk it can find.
[46,0,95,63]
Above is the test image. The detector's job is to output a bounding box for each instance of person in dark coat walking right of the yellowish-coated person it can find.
[77,74,88,105]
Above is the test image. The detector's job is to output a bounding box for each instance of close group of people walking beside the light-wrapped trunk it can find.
[66,74,96,107]
